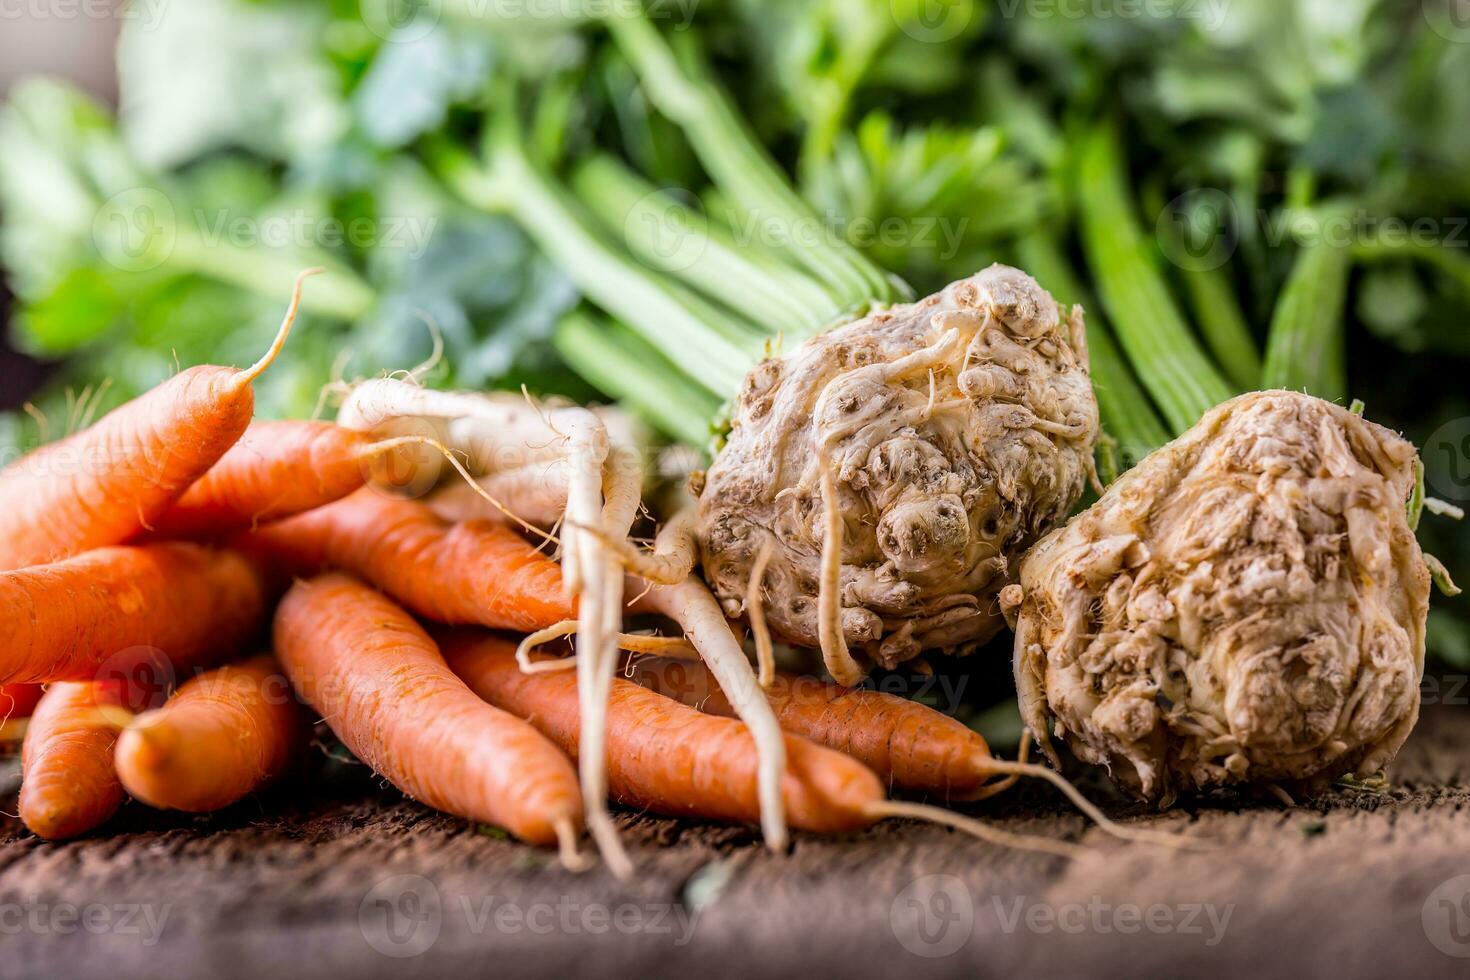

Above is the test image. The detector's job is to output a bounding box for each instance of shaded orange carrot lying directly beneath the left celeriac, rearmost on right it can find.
[628,657,998,799]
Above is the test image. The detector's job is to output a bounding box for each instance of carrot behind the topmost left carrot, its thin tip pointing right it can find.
[144,422,375,538]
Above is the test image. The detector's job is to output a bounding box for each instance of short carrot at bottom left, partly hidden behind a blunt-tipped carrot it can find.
[21,683,135,840]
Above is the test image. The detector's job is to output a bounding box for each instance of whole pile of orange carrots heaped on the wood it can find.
[0,271,1164,874]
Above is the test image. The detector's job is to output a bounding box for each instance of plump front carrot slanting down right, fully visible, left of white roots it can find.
[275,573,582,854]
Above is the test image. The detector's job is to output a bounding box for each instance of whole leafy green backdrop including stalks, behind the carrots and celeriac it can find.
[0,0,1470,667]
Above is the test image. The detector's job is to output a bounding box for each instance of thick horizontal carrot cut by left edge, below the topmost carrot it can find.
[0,544,266,683]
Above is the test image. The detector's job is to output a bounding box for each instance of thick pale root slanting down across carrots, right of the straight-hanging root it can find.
[648,576,788,851]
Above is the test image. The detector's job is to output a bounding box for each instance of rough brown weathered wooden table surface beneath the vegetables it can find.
[0,708,1470,980]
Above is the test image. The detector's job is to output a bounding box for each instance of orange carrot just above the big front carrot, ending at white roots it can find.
[251,489,573,632]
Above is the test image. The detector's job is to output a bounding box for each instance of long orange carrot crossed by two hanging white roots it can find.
[441,630,883,833]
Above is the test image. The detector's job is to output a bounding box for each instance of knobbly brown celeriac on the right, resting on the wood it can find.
[1001,391,1430,807]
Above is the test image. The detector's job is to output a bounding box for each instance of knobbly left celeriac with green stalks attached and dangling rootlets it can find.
[698,266,1098,667]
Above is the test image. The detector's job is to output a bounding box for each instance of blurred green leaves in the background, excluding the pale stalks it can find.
[0,0,1470,660]
